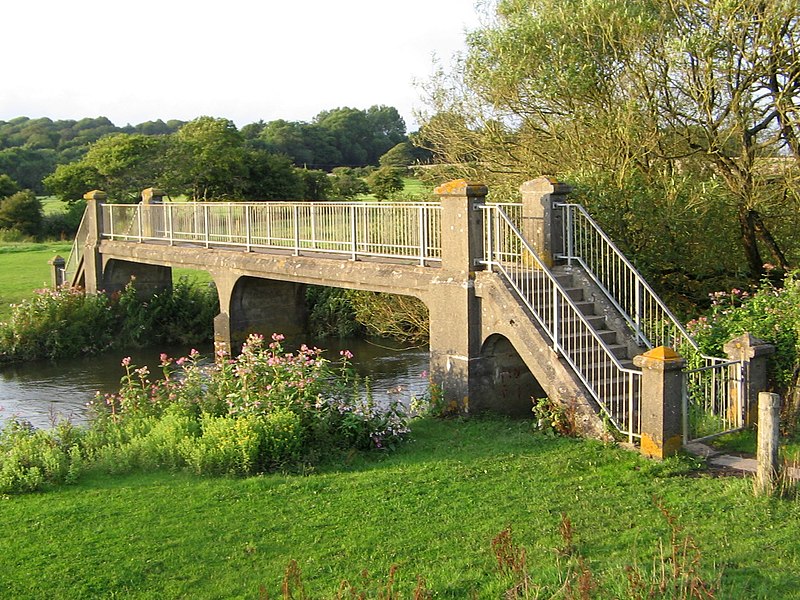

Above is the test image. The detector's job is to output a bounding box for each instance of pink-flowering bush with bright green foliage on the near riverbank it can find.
[87,334,409,475]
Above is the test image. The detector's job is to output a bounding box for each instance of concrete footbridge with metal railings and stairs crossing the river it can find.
[56,178,768,456]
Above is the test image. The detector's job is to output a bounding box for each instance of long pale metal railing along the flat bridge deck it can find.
[102,202,441,265]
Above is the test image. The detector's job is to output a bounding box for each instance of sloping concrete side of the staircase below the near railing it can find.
[475,271,606,438]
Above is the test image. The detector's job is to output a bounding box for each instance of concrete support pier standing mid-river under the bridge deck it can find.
[212,272,308,354]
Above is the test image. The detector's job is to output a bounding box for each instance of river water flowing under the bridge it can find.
[0,339,429,428]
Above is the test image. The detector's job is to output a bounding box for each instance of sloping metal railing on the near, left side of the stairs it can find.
[483,205,641,440]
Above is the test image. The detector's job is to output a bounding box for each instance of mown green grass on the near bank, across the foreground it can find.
[0,419,800,599]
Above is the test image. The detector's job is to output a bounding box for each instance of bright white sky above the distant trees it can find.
[0,0,478,131]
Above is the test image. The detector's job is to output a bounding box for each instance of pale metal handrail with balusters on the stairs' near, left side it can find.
[480,204,641,440]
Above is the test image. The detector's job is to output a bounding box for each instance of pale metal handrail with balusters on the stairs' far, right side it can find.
[555,202,704,360]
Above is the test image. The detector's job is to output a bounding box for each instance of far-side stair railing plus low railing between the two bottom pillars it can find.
[556,203,747,441]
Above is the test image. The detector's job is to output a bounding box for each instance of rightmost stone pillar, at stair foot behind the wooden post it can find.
[722,333,775,424]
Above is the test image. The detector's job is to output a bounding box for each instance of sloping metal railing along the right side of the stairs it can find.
[555,203,700,358]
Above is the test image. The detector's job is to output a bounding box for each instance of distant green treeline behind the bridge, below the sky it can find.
[0,106,434,202]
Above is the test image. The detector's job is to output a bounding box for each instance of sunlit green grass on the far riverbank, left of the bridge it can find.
[0,242,72,321]
